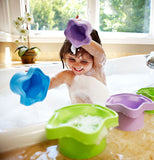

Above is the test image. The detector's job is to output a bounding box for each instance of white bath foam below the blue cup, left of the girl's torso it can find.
[0,85,71,132]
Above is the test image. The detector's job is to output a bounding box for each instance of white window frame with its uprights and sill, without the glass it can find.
[0,0,154,45]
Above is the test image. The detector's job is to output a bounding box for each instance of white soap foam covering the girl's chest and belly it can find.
[70,75,109,106]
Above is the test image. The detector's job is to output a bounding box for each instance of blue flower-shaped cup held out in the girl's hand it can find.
[10,67,50,106]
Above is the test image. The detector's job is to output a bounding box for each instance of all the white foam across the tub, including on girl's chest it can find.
[0,71,153,132]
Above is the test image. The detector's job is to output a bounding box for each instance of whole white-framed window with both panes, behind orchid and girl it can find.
[0,0,154,44]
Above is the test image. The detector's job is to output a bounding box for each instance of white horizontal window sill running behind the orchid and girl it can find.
[0,31,154,45]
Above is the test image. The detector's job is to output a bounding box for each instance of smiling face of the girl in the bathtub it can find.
[65,49,93,75]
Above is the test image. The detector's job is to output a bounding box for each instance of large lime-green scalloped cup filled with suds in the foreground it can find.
[46,104,118,159]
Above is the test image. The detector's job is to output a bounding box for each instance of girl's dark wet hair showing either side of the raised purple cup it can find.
[60,29,101,68]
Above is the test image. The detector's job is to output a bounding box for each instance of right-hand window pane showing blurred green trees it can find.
[99,0,151,33]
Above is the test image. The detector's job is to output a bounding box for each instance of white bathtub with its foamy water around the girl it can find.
[0,55,154,152]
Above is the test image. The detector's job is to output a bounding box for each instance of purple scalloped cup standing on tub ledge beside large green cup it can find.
[105,93,154,131]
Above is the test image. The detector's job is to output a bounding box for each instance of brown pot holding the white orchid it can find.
[21,50,37,64]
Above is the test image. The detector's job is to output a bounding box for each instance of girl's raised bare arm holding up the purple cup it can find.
[82,40,106,66]
